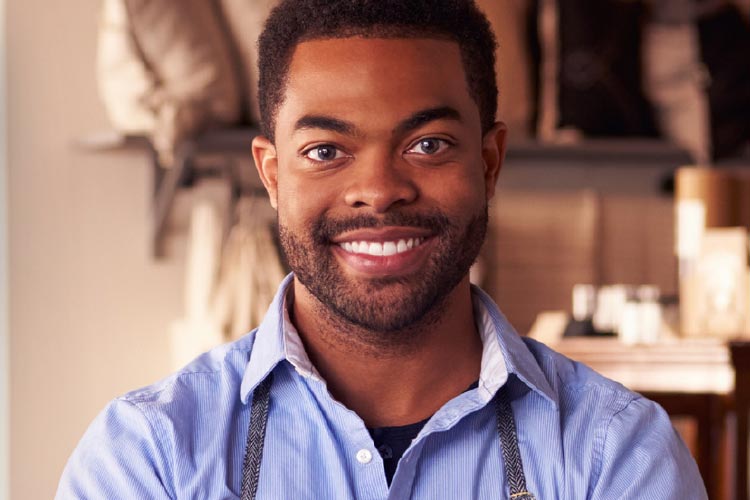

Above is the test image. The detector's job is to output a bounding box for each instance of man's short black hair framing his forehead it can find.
[258,0,497,141]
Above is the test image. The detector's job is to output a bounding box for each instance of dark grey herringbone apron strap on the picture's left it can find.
[240,373,273,500]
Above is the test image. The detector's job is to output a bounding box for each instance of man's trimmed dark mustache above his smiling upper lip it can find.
[312,211,454,245]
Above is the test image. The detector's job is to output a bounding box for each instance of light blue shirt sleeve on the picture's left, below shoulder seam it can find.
[55,399,171,500]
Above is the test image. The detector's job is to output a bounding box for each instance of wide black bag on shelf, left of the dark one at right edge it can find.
[558,0,657,137]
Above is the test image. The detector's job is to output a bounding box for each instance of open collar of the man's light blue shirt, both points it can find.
[240,274,557,404]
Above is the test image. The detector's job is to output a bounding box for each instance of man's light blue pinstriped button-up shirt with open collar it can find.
[57,276,707,500]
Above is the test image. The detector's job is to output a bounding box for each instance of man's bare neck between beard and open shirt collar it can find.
[291,277,482,427]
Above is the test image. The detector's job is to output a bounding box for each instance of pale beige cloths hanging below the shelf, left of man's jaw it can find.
[170,191,285,368]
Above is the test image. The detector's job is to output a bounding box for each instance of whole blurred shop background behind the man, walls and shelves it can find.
[0,0,750,500]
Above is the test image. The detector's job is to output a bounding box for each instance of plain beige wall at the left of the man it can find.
[8,0,187,499]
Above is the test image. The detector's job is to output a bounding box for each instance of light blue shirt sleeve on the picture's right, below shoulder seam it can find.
[590,398,708,500]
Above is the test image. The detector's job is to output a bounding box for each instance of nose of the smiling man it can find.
[344,155,419,213]
